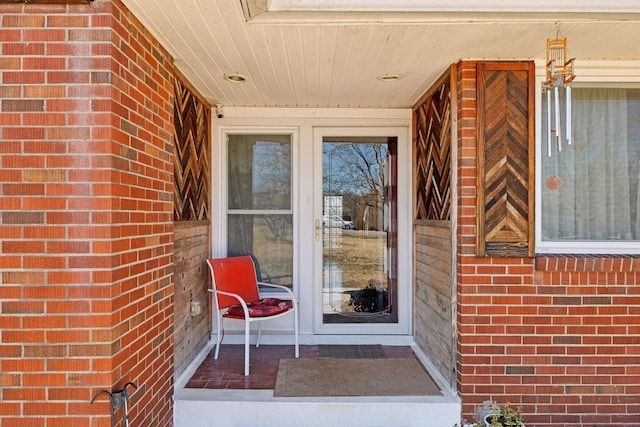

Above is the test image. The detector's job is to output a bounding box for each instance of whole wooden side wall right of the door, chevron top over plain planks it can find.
[413,68,456,385]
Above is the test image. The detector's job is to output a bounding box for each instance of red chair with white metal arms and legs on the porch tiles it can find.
[207,255,300,375]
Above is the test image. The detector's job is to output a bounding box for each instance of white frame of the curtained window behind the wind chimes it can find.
[535,61,640,255]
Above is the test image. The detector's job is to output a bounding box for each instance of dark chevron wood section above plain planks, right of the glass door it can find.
[413,72,451,220]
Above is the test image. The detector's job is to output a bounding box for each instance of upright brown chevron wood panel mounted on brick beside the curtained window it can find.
[476,62,534,257]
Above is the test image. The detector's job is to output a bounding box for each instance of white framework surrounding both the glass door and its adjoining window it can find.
[211,107,413,345]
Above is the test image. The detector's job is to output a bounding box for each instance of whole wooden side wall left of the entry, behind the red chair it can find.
[173,73,211,377]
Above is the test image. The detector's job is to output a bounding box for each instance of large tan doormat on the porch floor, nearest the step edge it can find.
[274,358,441,397]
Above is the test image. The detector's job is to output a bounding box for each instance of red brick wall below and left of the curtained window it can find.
[457,61,640,427]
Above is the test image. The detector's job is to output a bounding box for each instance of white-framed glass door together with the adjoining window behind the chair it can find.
[212,124,412,344]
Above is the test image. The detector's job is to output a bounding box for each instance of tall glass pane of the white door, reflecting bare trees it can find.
[322,136,398,323]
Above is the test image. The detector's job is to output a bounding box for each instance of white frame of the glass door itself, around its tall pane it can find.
[312,126,413,335]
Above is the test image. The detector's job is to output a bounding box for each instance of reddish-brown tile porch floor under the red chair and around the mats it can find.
[185,344,415,390]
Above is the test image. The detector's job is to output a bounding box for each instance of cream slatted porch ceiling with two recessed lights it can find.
[124,0,640,108]
